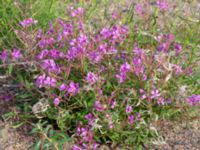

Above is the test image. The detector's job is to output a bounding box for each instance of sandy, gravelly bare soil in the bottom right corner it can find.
[152,118,200,150]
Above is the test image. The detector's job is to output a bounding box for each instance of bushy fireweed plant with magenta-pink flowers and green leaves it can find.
[0,1,200,150]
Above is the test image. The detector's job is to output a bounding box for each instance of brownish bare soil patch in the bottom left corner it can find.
[0,100,34,150]
